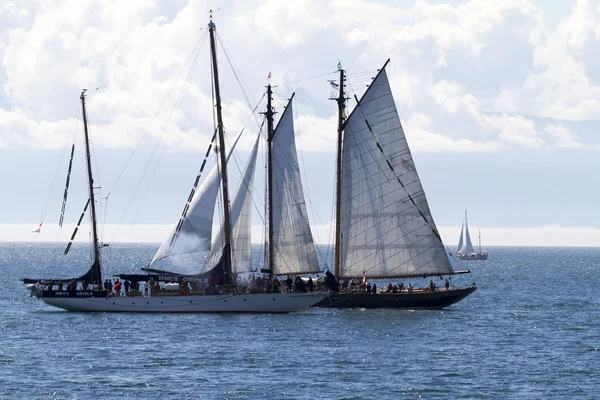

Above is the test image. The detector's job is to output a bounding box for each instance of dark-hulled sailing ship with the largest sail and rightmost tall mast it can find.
[317,59,476,308]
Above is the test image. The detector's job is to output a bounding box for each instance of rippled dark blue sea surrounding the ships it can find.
[0,243,600,399]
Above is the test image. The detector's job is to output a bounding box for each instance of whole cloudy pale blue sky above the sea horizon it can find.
[0,0,600,247]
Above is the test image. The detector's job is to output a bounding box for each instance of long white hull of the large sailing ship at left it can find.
[41,293,327,313]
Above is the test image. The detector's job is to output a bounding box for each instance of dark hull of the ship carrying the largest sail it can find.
[313,286,477,309]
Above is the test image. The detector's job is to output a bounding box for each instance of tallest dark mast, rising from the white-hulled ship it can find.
[208,10,233,284]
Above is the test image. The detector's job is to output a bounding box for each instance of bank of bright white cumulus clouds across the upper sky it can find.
[0,0,600,152]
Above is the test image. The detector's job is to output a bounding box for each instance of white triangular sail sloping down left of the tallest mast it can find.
[150,132,242,265]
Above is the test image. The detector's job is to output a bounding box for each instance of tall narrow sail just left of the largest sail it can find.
[271,102,321,275]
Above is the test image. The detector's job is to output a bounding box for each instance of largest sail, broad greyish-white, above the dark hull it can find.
[338,69,453,278]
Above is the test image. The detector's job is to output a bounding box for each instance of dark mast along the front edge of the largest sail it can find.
[331,64,346,278]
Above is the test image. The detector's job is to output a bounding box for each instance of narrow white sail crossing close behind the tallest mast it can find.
[202,136,260,274]
